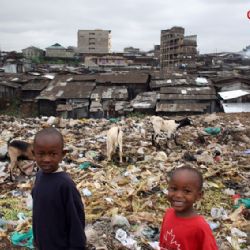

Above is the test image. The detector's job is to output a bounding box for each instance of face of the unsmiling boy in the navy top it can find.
[34,135,65,173]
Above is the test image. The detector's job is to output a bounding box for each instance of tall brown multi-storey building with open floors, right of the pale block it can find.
[160,27,197,74]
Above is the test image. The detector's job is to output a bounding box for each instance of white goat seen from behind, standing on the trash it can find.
[107,126,123,163]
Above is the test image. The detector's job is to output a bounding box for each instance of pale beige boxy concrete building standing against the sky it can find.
[77,30,111,54]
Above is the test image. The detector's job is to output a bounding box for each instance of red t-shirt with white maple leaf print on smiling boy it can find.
[160,208,218,250]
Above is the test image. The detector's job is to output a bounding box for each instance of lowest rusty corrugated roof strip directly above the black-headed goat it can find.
[156,103,210,112]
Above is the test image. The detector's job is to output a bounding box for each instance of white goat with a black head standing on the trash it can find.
[150,116,193,147]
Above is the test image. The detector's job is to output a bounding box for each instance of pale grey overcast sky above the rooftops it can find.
[0,0,250,53]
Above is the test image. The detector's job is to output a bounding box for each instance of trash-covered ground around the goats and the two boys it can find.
[0,113,250,250]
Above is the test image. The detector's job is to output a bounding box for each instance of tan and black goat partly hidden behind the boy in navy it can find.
[8,140,34,181]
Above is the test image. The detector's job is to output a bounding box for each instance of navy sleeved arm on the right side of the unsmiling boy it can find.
[63,185,86,250]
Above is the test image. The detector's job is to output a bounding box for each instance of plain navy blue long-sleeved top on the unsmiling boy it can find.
[32,171,86,250]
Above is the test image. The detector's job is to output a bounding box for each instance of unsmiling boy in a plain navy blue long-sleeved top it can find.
[32,128,86,250]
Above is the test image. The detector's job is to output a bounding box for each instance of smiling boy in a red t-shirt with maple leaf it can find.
[160,166,218,250]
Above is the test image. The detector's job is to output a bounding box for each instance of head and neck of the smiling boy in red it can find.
[168,170,202,217]
